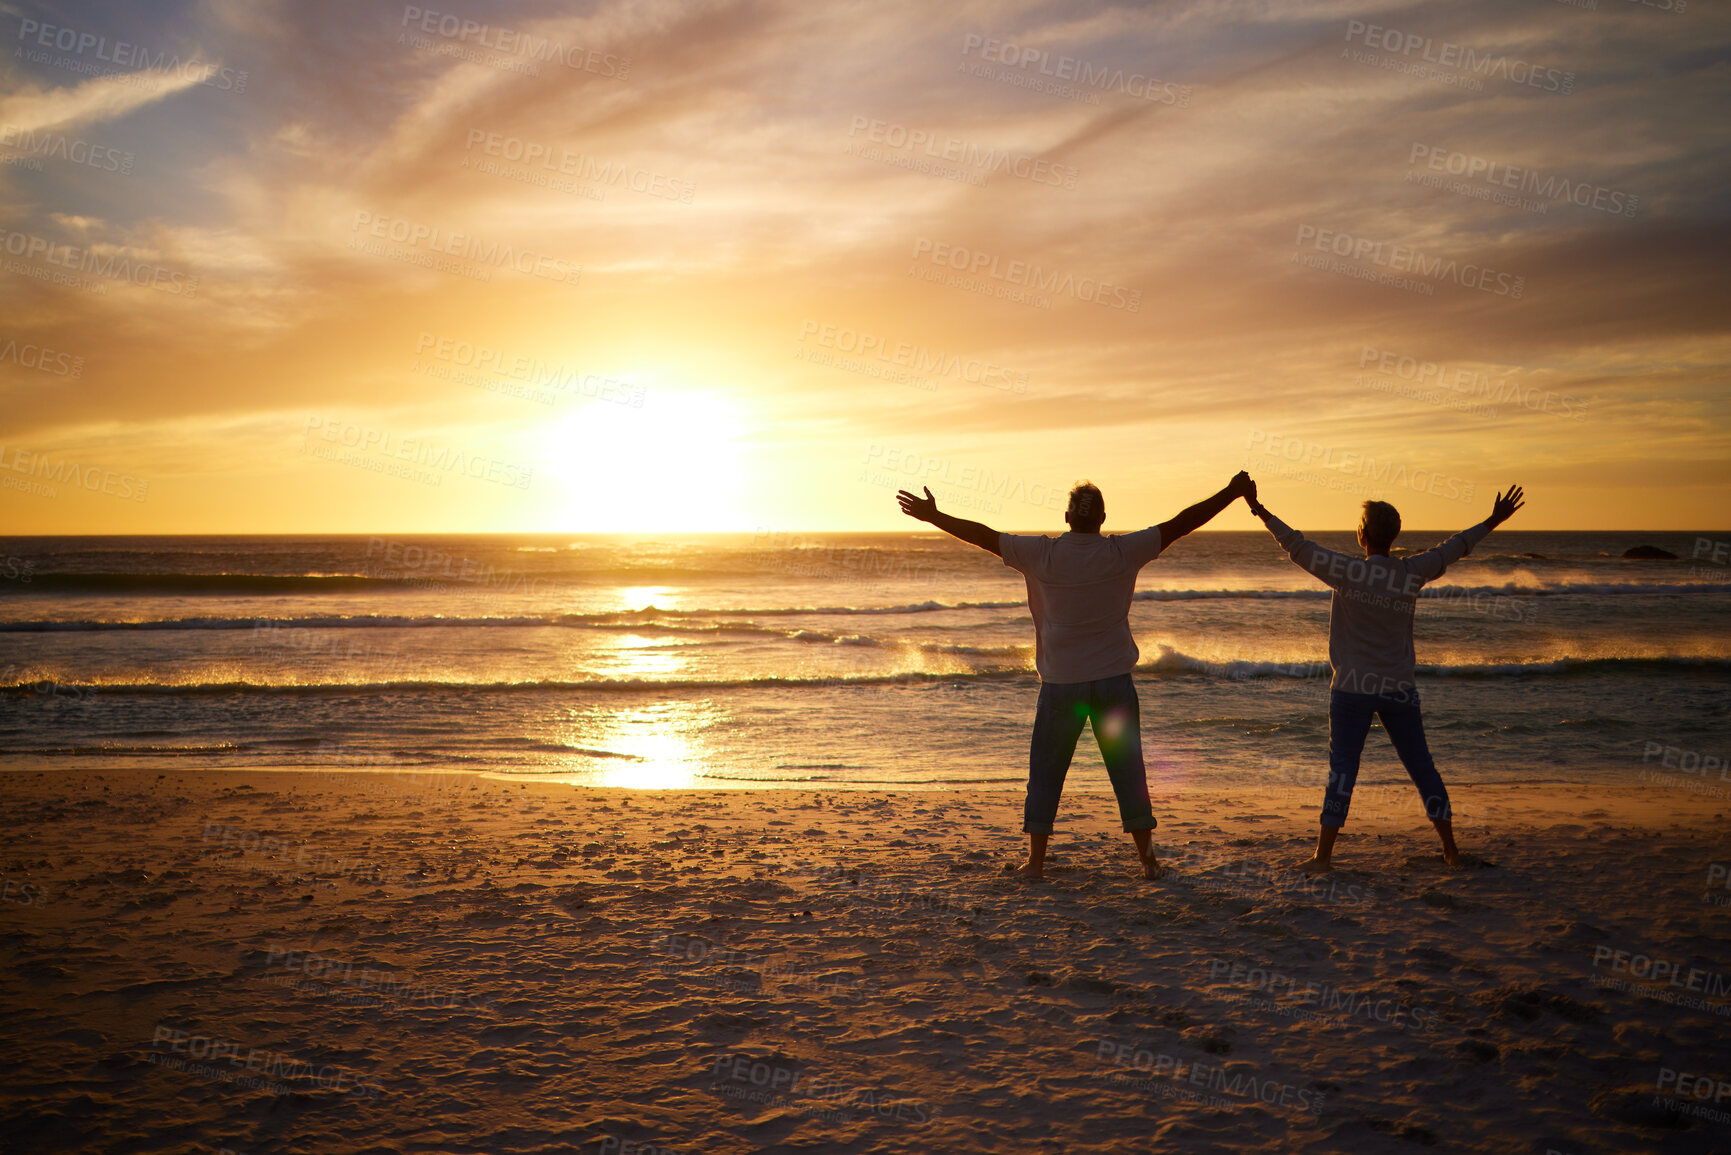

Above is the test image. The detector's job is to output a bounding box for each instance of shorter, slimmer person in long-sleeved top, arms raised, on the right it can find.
[1246,481,1525,873]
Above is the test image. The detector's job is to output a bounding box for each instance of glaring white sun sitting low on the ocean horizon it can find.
[538,386,750,533]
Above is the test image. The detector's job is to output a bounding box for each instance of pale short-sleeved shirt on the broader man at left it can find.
[997,526,1163,682]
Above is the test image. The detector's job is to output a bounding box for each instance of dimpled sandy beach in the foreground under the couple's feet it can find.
[0,771,1731,1155]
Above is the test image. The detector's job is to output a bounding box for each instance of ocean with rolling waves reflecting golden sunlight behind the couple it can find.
[0,530,1731,802]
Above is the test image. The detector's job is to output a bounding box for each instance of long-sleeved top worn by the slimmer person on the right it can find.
[1264,513,1490,698]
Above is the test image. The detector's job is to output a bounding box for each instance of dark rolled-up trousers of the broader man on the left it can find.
[1021,674,1158,835]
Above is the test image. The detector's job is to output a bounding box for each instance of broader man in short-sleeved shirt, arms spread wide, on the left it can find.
[895,473,1252,880]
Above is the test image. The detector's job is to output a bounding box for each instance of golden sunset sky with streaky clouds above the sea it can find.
[0,0,1731,533]
